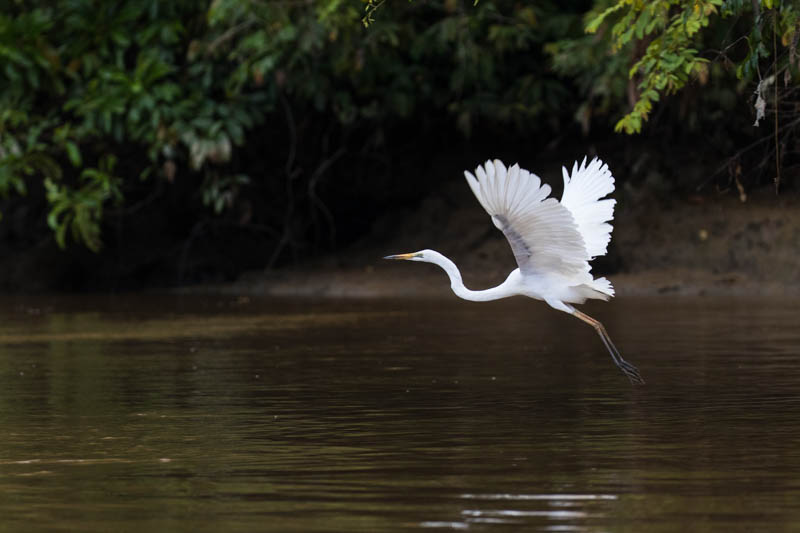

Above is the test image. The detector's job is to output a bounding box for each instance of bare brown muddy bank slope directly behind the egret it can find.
[217,185,800,297]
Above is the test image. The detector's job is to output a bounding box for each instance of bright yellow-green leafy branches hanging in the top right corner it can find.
[548,0,800,133]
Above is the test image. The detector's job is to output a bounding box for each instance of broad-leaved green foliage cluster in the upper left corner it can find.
[0,0,264,250]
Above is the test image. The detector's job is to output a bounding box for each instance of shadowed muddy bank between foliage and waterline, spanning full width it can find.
[0,150,800,297]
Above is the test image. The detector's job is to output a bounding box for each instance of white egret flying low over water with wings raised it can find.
[386,158,644,384]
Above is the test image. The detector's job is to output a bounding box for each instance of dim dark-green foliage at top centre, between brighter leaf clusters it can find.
[209,0,577,132]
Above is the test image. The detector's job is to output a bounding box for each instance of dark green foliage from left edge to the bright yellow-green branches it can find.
[0,0,592,249]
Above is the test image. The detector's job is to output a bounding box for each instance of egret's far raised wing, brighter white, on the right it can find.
[561,158,617,258]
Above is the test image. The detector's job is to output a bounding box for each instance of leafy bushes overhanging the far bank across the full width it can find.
[0,0,800,262]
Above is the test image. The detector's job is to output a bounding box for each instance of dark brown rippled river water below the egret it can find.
[0,296,800,532]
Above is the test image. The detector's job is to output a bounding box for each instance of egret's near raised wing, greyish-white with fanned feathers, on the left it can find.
[464,160,592,283]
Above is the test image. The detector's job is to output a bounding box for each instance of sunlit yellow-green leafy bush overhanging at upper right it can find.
[564,0,800,133]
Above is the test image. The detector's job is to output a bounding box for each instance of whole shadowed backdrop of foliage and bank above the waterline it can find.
[0,0,800,291]
